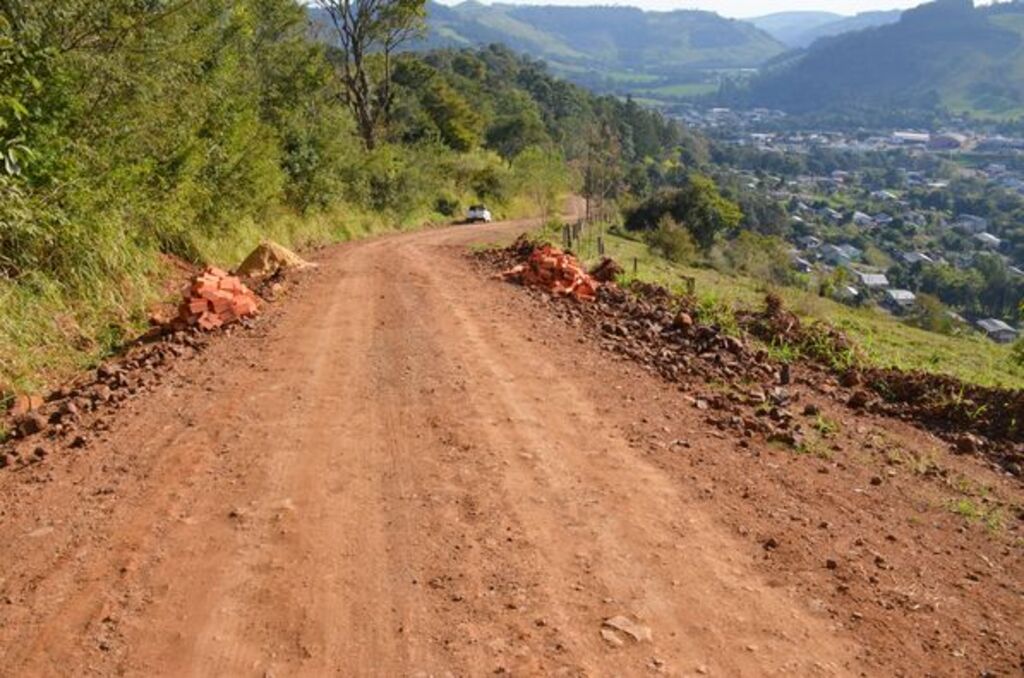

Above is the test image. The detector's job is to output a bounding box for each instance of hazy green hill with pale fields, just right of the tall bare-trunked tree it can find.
[407,0,785,77]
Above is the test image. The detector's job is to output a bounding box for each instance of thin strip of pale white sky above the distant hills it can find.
[432,0,982,17]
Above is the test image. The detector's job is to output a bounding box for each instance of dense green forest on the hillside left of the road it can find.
[0,0,707,387]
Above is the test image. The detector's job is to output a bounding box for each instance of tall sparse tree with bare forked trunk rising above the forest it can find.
[316,0,426,150]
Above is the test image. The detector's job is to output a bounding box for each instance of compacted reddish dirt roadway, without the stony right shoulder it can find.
[0,224,905,676]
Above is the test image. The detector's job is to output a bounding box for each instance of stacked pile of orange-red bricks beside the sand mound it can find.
[178,266,259,331]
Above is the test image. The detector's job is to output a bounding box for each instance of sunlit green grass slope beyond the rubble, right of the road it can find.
[581,228,1024,388]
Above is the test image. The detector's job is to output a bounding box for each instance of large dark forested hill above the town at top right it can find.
[746,0,1024,119]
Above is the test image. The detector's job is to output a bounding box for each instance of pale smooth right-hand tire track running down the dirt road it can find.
[396,236,849,675]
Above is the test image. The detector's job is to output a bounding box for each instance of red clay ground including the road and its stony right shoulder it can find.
[0,223,1024,677]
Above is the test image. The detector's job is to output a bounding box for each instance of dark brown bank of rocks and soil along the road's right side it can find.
[481,239,1024,475]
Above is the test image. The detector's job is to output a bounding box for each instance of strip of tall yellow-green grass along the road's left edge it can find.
[0,182,552,392]
